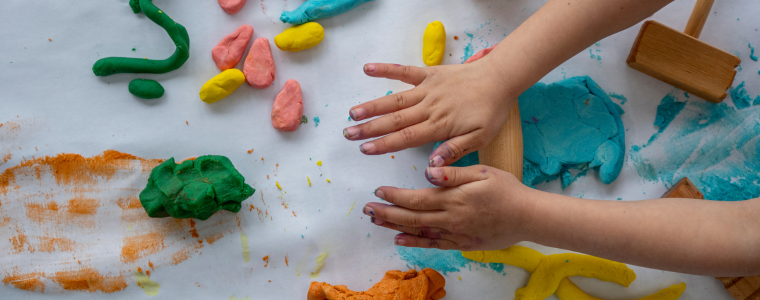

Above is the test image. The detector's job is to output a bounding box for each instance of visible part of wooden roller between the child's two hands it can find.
[478,103,523,181]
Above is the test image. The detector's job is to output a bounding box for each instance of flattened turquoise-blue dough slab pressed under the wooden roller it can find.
[436,76,625,188]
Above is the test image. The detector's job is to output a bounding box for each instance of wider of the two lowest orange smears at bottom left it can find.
[51,268,127,293]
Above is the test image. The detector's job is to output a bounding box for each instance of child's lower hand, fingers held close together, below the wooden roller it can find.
[363,165,534,250]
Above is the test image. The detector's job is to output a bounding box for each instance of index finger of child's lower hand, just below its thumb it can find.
[375,186,444,210]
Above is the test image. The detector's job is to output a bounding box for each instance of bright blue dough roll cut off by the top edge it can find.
[280,0,372,25]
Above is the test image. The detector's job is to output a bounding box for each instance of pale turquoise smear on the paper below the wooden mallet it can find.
[630,83,760,201]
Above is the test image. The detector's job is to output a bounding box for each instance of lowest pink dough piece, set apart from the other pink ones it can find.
[272,79,303,131]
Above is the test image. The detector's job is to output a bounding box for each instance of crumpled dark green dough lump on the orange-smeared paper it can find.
[140,155,256,220]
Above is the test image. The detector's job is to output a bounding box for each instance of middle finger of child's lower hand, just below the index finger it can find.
[362,202,446,227]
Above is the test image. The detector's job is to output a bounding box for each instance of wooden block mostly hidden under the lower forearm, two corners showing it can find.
[662,177,760,300]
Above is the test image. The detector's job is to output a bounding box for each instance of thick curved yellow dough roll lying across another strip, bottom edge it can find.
[515,253,636,300]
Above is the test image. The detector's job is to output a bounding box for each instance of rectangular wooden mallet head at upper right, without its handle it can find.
[626,20,741,103]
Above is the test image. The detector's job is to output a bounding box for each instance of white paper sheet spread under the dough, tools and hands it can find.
[0,0,760,299]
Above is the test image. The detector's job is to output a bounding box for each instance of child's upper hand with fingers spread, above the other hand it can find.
[343,59,517,167]
